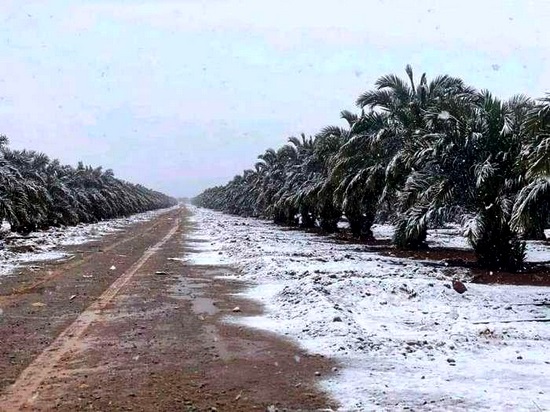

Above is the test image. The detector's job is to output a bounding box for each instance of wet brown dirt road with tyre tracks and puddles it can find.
[0,208,335,411]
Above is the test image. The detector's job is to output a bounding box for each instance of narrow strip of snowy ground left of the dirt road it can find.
[0,209,177,277]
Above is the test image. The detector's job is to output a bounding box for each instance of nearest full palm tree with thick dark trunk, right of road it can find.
[396,91,530,270]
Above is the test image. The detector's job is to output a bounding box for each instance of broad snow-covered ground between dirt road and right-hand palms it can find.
[188,208,550,411]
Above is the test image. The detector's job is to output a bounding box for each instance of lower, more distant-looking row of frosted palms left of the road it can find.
[0,136,176,234]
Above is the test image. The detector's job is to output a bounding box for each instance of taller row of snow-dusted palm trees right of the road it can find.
[194,66,550,271]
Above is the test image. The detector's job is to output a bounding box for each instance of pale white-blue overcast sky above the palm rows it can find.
[0,0,550,196]
